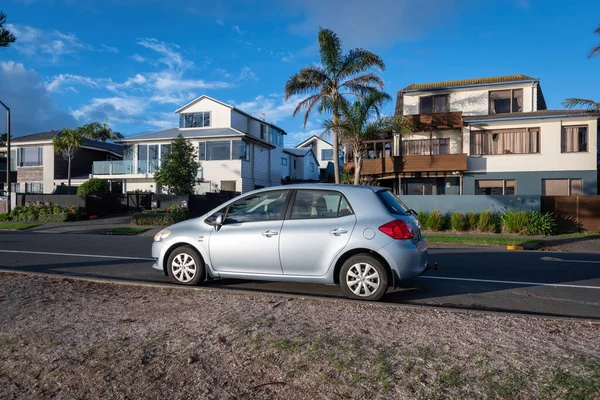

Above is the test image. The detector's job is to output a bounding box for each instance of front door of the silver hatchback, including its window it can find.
[208,190,289,275]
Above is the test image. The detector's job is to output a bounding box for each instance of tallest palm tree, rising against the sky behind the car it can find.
[285,28,385,183]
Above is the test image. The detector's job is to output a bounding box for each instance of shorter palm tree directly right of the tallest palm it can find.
[324,92,412,185]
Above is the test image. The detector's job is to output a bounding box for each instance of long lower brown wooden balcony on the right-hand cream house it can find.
[361,154,467,175]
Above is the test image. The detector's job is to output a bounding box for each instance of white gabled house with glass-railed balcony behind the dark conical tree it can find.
[93,95,286,193]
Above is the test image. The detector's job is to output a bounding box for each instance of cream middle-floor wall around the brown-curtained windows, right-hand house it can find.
[463,117,598,172]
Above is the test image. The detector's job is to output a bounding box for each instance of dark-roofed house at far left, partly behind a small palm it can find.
[0,131,123,194]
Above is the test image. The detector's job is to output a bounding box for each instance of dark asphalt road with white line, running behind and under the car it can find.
[0,232,600,319]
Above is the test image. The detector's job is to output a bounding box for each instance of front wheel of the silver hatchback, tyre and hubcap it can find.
[167,246,205,286]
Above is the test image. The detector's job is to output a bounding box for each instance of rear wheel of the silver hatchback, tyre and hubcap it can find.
[339,254,388,301]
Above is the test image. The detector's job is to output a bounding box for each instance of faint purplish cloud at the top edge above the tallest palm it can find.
[287,0,456,47]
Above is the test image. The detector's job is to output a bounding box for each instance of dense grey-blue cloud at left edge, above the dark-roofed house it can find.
[0,61,76,136]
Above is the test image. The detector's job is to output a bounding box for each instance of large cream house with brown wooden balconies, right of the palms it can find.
[354,75,600,195]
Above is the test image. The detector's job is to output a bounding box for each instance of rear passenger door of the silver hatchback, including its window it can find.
[279,189,356,276]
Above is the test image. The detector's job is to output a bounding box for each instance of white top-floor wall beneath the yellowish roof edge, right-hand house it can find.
[404,84,537,115]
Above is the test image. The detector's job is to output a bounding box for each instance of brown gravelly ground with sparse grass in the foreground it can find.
[0,273,600,399]
